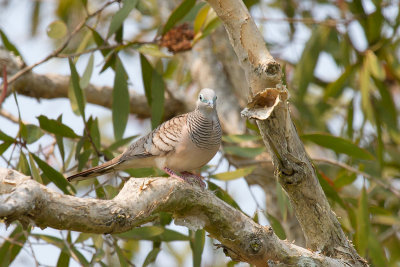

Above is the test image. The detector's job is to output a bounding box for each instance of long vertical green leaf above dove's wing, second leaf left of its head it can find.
[112,59,130,140]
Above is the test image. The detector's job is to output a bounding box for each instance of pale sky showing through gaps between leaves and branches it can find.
[0,0,388,267]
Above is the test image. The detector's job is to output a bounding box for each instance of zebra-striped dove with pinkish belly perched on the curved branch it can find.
[67,88,221,187]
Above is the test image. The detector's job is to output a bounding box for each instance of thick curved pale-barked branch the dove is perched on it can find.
[0,168,354,266]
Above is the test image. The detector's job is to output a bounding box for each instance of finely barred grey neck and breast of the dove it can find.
[187,109,222,149]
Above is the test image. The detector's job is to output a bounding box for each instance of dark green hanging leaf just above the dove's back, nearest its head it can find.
[140,54,164,129]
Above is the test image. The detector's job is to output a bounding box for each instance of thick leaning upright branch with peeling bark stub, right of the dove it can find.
[208,0,366,266]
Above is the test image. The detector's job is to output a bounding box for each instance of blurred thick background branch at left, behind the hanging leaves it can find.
[0,48,188,118]
